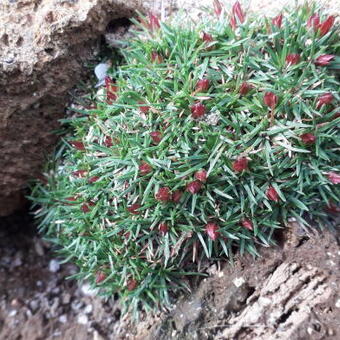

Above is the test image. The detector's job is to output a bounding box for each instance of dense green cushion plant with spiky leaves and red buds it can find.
[32,1,340,318]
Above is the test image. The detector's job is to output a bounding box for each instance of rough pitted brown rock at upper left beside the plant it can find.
[0,0,153,216]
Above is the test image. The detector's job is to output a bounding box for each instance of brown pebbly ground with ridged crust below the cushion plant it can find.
[0,209,340,340]
